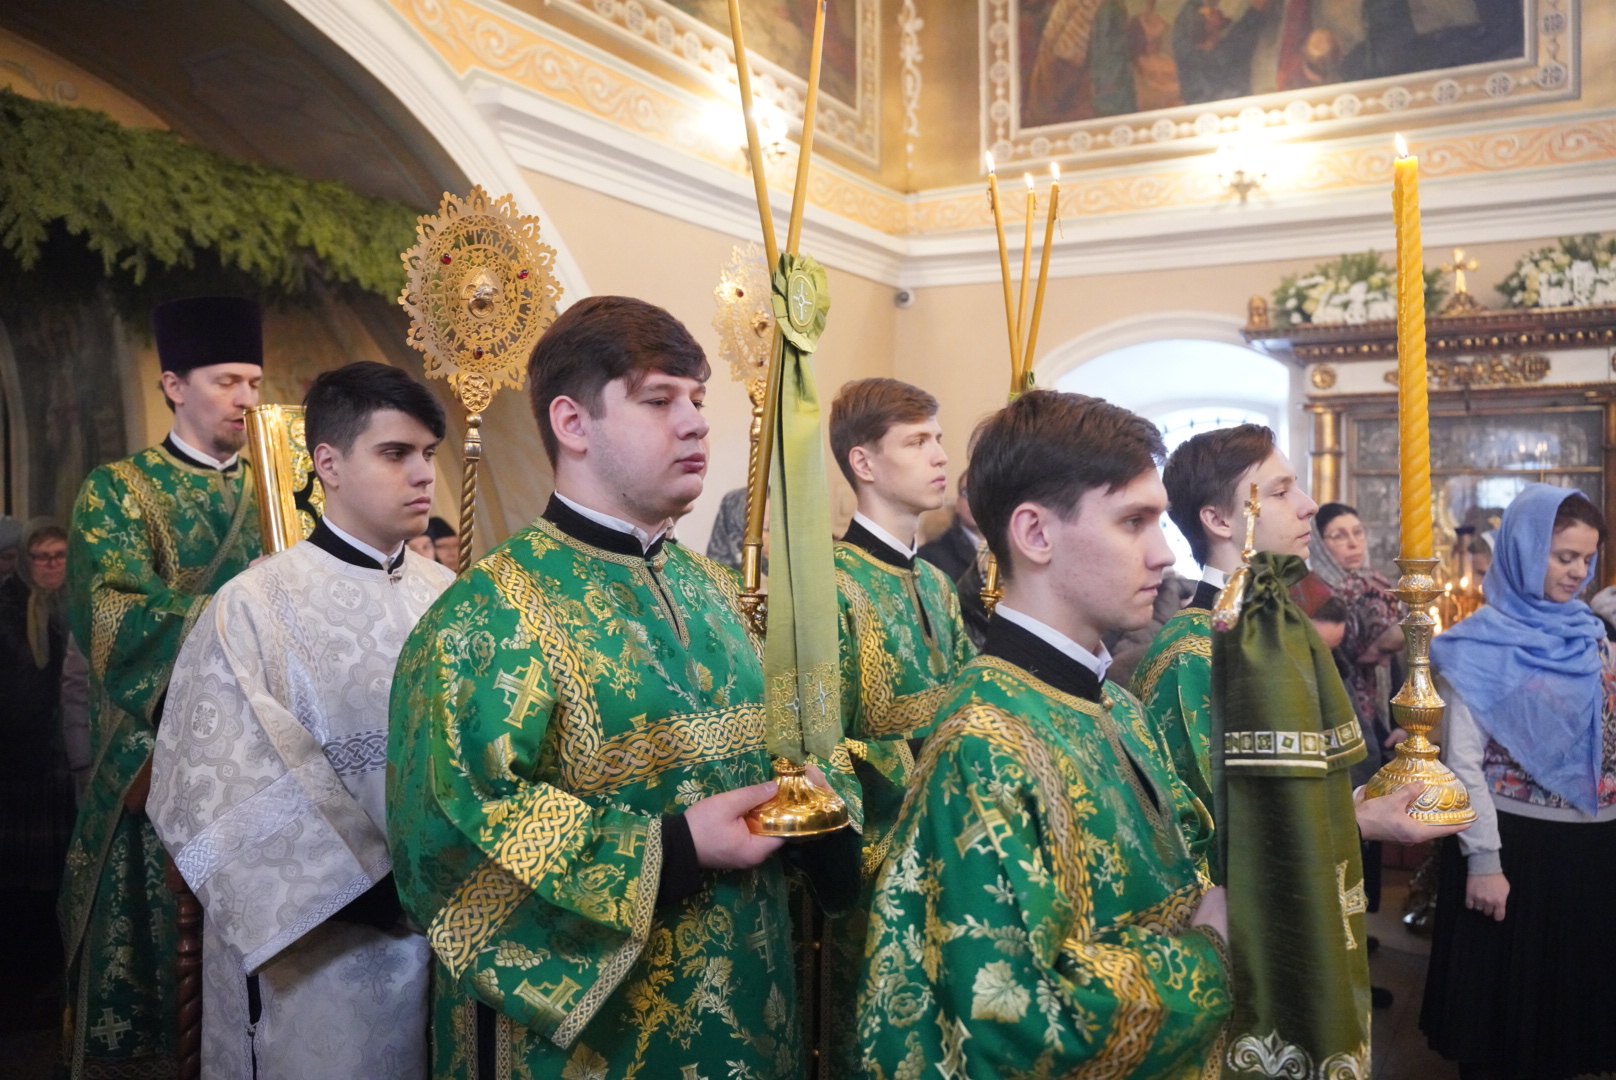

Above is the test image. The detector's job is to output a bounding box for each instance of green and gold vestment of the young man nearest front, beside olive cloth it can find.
[858,618,1230,1080]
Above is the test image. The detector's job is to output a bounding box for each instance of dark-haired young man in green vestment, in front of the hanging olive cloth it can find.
[858,390,1230,1080]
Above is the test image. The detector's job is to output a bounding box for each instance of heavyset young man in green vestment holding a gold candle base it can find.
[388,296,820,1080]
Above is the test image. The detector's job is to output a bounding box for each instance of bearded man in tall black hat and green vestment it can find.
[60,296,263,1077]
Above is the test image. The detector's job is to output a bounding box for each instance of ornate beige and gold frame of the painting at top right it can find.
[978,0,1580,170]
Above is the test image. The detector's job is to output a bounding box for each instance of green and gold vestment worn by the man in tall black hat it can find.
[58,445,262,1077]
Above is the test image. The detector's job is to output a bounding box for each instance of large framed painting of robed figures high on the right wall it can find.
[978,0,1580,168]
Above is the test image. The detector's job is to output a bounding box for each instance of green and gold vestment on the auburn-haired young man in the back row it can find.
[818,521,976,1080]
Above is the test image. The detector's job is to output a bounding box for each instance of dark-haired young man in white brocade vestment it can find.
[150,364,454,1080]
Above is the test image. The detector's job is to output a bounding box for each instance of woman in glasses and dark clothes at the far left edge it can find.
[0,521,73,1023]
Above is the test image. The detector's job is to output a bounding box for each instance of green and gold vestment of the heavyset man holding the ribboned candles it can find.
[388,504,814,1080]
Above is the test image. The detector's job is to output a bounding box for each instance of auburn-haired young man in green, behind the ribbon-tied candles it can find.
[818,378,976,1077]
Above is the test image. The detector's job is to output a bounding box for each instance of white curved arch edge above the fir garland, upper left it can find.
[286,0,590,307]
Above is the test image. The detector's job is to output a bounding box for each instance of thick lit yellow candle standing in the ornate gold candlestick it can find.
[1391,136,1432,559]
